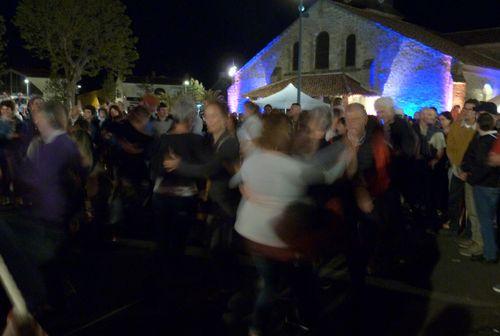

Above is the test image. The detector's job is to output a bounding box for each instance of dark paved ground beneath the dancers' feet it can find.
[0,207,500,336]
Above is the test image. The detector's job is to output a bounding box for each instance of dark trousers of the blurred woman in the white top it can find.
[251,256,318,335]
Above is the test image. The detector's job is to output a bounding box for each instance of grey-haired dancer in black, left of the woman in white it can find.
[151,98,206,275]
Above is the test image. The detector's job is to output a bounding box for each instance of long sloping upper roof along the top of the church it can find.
[331,1,500,68]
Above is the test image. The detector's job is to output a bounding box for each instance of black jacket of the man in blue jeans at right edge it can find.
[462,134,500,188]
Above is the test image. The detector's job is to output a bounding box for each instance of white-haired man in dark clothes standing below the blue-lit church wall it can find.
[375,97,418,204]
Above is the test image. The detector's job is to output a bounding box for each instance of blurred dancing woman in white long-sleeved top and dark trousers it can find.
[232,115,345,335]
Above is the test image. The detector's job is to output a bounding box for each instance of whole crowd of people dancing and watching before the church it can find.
[0,91,500,335]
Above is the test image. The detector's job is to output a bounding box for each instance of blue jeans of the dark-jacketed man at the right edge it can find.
[474,186,500,260]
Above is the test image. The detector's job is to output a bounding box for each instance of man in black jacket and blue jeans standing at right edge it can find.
[462,105,500,263]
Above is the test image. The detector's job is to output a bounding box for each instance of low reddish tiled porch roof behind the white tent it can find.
[243,73,376,98]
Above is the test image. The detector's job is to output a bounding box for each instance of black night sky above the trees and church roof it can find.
[0,0,500,87]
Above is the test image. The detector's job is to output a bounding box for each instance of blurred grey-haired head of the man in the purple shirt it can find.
[33,102,68,137]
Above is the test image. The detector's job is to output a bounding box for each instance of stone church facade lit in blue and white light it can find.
[228,0,500,115]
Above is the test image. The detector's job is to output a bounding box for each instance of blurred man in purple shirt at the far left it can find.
[0,103,84,309]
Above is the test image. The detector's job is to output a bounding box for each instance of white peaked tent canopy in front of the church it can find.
[254,83,330,110]
